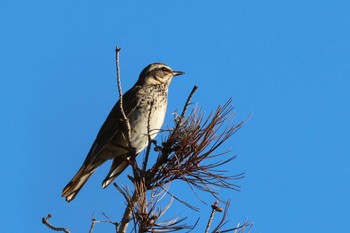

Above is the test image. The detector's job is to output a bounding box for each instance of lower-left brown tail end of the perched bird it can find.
[62,164,96,202]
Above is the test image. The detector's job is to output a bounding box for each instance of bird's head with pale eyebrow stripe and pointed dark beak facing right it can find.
[138,63,184,85]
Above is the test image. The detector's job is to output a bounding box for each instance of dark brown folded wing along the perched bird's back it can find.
[84,86,141,164]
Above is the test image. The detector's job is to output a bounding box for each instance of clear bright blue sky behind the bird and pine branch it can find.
[0,0,350,233]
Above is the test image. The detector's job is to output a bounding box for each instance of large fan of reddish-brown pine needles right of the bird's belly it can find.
[147,100,244,195]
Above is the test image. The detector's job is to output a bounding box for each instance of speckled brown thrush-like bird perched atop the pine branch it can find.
[62,63,184,202]
